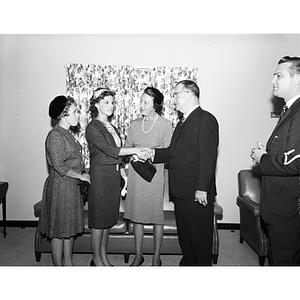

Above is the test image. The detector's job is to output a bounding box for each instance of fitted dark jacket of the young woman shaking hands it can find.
[86,119,122,166]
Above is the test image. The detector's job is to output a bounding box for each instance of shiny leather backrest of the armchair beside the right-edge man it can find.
[238,170,261,204]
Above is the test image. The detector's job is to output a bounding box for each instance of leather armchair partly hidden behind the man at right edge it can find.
[236,170,268,266]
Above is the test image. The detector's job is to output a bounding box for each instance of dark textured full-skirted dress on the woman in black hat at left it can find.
[40,125,84,238]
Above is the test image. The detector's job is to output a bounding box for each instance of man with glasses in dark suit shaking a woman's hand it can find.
[143,80,219,266]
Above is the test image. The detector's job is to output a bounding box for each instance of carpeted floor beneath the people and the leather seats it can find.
[0,227,268,270]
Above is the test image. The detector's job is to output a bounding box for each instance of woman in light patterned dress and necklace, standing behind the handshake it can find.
[124,87,172,266]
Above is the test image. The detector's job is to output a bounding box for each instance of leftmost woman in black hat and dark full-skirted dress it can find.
[40,96,90,266]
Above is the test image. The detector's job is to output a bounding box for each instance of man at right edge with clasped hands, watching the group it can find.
[251,56,300,266]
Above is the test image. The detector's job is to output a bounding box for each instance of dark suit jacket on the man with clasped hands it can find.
[260,98,300,226]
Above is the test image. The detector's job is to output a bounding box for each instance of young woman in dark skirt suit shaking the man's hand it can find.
[86,88,145,266]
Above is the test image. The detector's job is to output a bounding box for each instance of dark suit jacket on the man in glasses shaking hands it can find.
[154,107,219,201]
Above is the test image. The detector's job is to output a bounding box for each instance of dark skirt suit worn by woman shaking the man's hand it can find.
[86,119,122,229]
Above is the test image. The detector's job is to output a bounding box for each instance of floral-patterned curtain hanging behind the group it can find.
[65,63,198,167]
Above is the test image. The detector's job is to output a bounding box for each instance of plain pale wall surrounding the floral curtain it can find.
[0,34,300,223]
